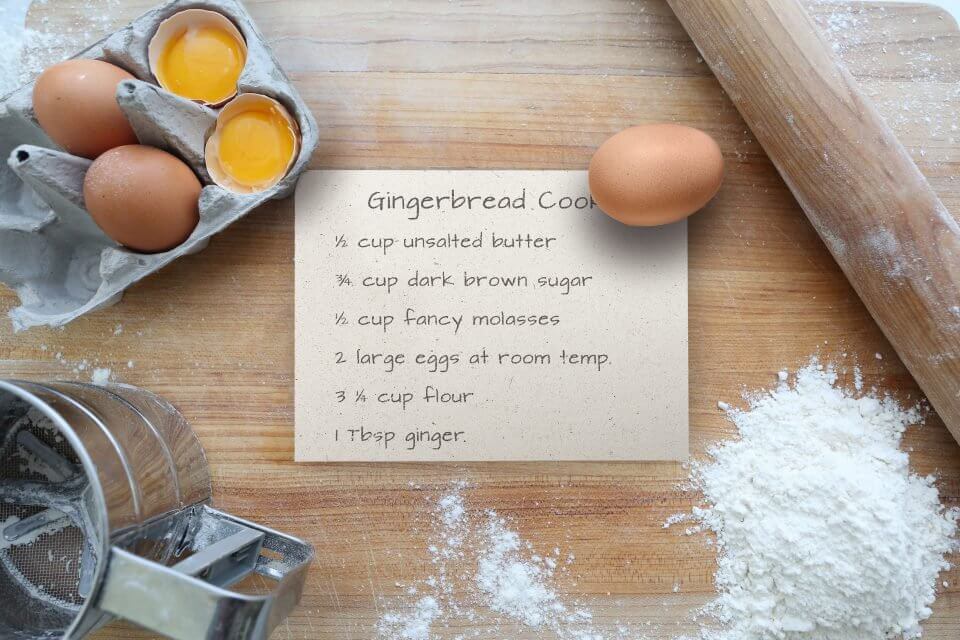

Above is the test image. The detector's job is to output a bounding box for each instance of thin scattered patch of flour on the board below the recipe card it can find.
[377,484,616,640]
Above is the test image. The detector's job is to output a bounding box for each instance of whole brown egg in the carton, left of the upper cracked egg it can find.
[33,59,137,159]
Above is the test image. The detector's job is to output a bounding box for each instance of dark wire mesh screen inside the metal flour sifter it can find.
[0,411,86,610]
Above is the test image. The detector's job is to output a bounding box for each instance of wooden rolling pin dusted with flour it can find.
[667,0,960,441]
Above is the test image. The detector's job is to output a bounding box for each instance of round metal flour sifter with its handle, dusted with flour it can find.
[0,381,313,640]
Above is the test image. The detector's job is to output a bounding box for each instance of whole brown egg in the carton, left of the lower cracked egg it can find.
[83,145,202,253]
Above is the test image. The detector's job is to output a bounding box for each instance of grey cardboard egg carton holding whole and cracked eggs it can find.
[0,0,319,331]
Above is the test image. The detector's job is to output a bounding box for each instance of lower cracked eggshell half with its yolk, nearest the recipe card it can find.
[204,93,301,194]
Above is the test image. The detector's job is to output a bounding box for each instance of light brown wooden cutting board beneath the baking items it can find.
[7,0,960,640]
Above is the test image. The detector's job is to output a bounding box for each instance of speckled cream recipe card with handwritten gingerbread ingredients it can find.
[295,171,689,461]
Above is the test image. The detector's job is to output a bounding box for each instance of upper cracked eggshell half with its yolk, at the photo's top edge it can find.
[147,9,247,107]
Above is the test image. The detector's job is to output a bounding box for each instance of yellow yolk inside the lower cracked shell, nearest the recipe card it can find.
[218,107,296,187]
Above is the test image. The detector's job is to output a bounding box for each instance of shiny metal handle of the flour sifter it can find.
[96,507,313,640]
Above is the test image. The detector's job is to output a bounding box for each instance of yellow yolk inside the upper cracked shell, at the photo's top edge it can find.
[157,26,246,103]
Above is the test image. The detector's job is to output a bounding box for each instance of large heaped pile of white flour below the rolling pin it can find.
[674,363,957,640]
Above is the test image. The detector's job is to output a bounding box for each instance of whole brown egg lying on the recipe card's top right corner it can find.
[590,124,723,227]
